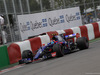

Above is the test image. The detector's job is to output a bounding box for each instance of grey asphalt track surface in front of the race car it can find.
[0,41,100,75]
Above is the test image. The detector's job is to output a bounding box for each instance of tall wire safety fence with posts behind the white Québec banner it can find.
[0,0,100,45]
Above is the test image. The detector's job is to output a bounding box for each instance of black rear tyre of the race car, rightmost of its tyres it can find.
[76,37,89,50]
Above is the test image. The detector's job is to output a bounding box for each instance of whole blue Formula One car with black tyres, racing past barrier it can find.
[20,34,89,63]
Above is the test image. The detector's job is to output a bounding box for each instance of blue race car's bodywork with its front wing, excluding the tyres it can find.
[19,34,76,64]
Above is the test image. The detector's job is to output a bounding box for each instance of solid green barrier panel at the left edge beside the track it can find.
[0,46,10,68]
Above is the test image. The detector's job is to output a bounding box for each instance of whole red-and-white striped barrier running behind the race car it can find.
[8,22,100,64]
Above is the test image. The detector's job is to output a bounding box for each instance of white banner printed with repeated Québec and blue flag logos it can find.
[18,7,82,40]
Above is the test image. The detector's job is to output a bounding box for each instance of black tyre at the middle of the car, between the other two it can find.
[53,44,64,57]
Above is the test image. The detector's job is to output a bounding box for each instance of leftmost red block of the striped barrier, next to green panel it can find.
[8,43,21,64]
